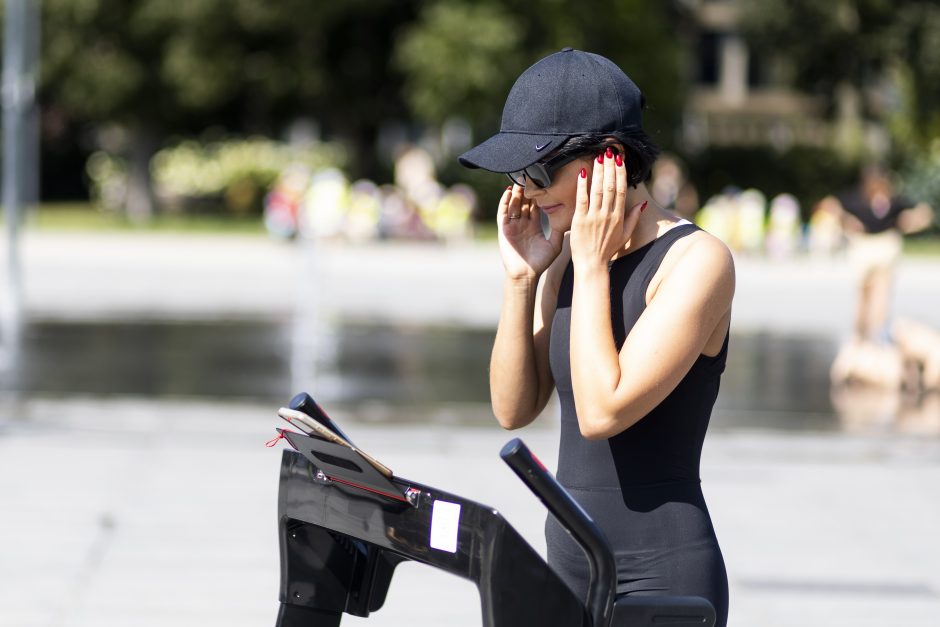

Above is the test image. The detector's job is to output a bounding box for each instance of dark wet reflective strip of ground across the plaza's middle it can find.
[0,320,940,434]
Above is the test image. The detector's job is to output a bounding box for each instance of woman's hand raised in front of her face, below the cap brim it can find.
[496,185,564,279]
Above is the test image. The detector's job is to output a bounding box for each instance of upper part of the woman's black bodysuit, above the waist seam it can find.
[549,223,728,498]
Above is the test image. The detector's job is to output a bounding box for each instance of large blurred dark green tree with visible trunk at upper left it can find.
[40,0,417,219]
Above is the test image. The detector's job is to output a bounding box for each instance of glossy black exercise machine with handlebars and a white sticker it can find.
[277,398,715,627]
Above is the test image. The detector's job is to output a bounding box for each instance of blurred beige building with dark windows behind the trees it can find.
[681,0,887,161]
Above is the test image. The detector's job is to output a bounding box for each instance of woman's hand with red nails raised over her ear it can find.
[571,148,642,267]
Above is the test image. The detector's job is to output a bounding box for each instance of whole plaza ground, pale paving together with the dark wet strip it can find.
[0,235,940,627]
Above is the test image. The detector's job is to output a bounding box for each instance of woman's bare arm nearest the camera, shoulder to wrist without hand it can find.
[571,233,734,439]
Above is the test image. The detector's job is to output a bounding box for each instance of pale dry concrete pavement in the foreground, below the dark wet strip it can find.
[0,399,940,627]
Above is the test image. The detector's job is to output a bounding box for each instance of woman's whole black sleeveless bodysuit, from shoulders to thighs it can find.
[546,224,728,627]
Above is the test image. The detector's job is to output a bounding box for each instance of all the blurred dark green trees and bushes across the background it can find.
[40,0,940,229]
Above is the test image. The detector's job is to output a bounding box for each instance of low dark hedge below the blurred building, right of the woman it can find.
[687,147,858,220]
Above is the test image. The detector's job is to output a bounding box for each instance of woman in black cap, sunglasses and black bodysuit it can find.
[460,48,734,625]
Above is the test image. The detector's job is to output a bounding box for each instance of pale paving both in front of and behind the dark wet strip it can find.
[0,235,940,627]
